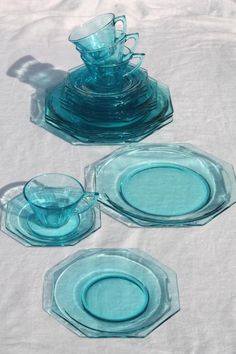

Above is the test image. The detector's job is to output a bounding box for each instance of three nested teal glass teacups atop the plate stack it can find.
[69,13,144,86]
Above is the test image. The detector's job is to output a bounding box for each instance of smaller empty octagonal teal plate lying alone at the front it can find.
[43,249,180,338]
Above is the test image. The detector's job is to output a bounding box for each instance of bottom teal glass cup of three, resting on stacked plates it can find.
[85,47,145,86]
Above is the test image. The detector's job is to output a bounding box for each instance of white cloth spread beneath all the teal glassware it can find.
[0,0,236,354]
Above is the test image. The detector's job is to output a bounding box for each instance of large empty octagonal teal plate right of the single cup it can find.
[86,144,236,227]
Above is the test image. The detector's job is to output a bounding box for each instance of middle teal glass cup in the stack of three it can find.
[79,31,139,65]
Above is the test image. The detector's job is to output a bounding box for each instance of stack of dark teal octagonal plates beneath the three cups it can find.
[44,66,173,144]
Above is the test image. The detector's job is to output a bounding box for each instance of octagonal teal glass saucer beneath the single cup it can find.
[4,193,100,246]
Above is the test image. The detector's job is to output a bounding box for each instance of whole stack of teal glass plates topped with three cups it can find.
[40,14,173,145]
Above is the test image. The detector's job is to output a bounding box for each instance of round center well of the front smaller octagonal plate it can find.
[81,272,149,321]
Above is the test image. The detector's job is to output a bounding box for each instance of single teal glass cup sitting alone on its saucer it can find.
[23,173,98,228]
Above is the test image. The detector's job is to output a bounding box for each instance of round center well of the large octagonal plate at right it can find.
[120,164,210,217]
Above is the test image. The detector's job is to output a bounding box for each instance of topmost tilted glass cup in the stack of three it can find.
[69,13,126,51]
